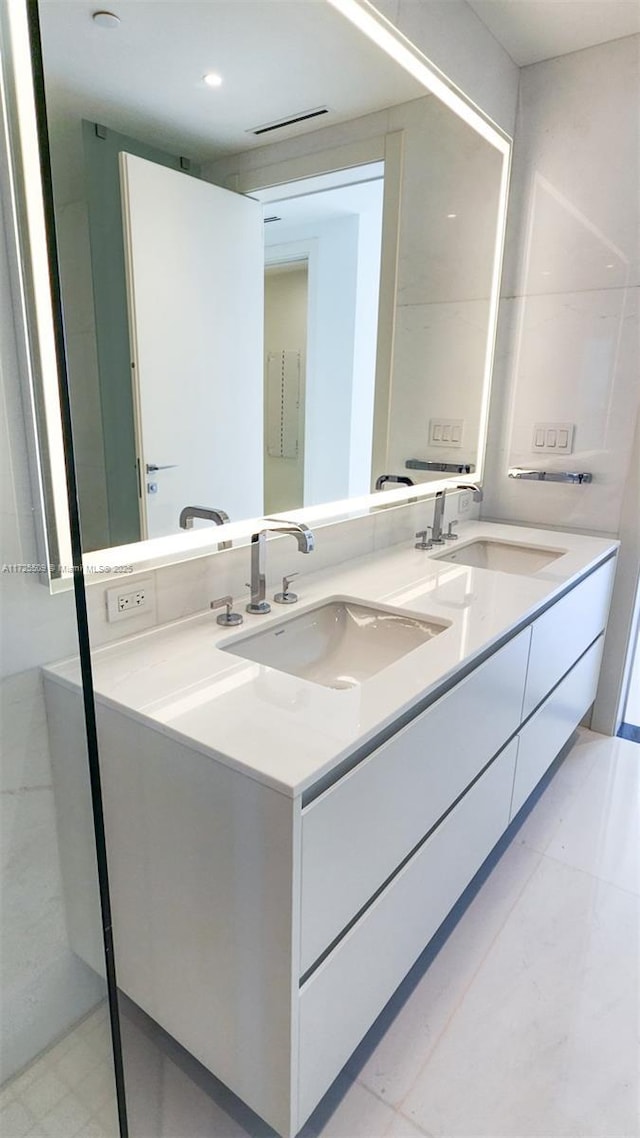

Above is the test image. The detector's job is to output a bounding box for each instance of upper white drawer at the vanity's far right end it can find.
[523,558,615,718]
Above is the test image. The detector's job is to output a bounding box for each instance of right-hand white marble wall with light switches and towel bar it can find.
[483,36,640,731]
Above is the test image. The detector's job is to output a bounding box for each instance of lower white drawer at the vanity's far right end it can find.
[511,636,605,818]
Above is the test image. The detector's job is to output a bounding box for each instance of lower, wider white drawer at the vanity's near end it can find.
[298,740,517,1125]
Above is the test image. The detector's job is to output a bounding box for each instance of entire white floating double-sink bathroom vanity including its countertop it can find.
[46,522,617,1136]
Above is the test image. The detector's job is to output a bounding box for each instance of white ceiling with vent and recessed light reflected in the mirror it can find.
[40,0,426,175]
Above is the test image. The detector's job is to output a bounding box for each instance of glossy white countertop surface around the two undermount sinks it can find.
[44,522,618,797]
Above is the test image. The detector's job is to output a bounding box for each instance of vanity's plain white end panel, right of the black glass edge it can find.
[98,707,297,1133]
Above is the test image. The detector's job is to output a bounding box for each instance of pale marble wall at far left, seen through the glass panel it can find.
[0,182,102,1082]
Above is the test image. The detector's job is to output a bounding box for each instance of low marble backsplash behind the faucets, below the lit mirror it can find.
[87,490,479,649]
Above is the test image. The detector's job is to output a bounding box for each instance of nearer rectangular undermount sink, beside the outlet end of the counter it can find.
[221,599,449,688]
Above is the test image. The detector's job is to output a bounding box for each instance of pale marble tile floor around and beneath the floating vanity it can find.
[0,731,640,1138]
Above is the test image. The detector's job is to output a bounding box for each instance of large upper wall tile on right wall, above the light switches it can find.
[504,35,640,296]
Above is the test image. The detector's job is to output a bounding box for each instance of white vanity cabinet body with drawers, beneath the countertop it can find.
[46,546,615,1136]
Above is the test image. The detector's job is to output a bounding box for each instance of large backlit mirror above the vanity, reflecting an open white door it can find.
[24,0,509,569]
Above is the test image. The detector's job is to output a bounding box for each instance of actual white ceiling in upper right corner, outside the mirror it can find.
[467,0,640,66]
